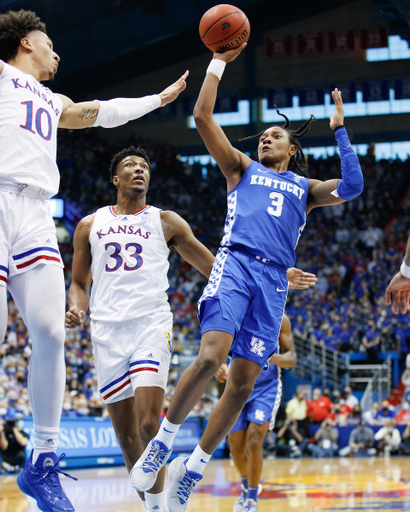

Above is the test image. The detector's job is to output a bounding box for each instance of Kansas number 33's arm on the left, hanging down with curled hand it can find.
[65,214,95,329]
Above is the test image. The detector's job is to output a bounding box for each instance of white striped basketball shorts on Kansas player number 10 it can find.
[0,190,64,286]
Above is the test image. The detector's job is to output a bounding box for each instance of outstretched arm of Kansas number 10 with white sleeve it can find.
[58,71,189,129]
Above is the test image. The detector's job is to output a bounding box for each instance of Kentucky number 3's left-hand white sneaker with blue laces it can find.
[130,439,172,492]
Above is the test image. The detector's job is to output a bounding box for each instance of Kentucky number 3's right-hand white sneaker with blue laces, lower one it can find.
[164,457,202,512]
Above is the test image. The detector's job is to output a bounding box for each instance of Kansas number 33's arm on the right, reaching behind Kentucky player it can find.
[161,211,215,278]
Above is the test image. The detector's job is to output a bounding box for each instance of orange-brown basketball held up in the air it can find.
[199,4,251,52]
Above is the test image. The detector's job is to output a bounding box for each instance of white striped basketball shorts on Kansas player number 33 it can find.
[91,311,172,404]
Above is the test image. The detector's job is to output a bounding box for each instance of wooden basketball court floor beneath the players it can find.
[0,457,410,512]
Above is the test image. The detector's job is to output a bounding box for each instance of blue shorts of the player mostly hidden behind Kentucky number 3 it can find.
[231,379,282,434]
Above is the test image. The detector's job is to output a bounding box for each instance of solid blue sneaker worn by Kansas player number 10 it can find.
[17,451,77,512]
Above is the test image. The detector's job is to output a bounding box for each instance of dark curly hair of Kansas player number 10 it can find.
[0,9,46,62]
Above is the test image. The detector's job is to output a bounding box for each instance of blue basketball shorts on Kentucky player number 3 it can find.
[198,248,288,368]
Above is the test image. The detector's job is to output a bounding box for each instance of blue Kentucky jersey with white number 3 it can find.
[221,161,309,267]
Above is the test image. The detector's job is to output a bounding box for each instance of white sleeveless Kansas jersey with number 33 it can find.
[90,206,170,322]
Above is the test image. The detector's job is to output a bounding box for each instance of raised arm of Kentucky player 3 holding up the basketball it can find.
[194,43,251,192]
